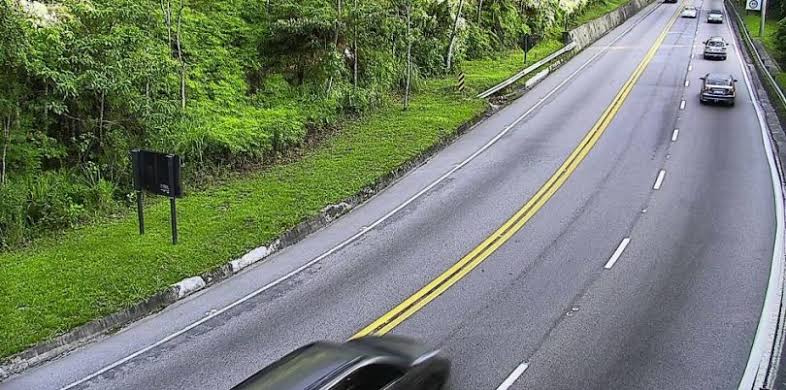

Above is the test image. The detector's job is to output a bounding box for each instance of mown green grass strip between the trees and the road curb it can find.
[0,2,622,357]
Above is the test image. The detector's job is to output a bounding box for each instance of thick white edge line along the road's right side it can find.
[724,5,784,390]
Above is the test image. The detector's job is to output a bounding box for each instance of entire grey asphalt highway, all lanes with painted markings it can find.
[0,0,777,389]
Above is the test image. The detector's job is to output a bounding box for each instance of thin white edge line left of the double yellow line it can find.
[60,5,668,390]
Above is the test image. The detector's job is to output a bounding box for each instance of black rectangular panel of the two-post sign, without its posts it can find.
[131,150,183,198]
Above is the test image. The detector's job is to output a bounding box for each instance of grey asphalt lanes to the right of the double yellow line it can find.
[388,1,775,389]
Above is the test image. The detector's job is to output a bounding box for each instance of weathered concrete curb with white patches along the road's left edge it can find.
[0,0,655,382]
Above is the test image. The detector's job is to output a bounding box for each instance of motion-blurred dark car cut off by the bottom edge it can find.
[233,336,450,390]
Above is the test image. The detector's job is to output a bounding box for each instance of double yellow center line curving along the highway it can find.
[352,5,677,338]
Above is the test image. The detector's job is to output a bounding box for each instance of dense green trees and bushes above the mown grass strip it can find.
[0,0,596,248]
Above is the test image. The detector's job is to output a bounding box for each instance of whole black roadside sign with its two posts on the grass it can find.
[131,149,183,245]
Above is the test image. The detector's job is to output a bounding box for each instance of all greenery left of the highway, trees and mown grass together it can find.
[0,0,632,357]
